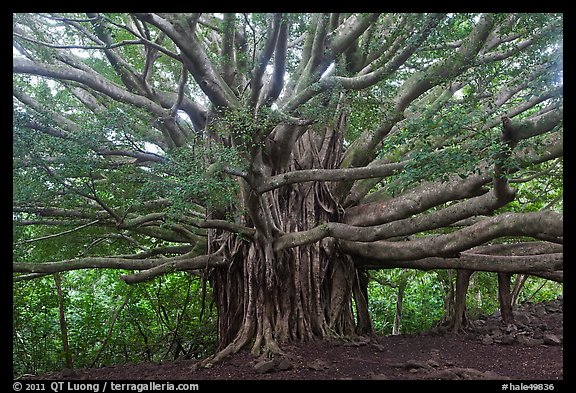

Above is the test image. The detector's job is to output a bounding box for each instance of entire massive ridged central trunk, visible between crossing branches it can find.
[209,125,362,362]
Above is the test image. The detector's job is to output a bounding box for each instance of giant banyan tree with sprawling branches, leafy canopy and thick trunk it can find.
[13,13,563,361]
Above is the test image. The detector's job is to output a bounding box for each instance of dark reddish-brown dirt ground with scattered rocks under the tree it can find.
[31,299,564,381]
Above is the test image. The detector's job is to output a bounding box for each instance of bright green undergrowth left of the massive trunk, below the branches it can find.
[13,270,216,376]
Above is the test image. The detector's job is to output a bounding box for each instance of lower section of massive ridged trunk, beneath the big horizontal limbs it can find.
[207,213,360,355]
